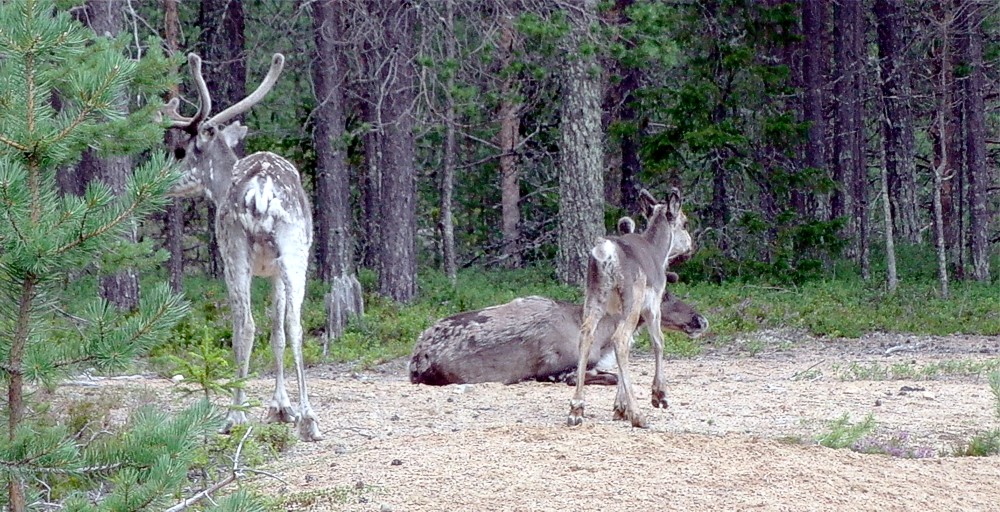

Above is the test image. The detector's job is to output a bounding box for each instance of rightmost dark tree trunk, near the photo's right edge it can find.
[960,0,993,281]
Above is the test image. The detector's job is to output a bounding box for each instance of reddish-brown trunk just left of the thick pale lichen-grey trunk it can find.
[499,16,521,268]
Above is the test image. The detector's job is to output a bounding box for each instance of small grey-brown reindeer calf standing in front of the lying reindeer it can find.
[566,188,693,428]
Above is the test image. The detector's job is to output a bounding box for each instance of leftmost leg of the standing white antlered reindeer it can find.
[221,247,255,434]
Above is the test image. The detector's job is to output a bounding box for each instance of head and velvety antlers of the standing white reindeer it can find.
[157,53,285,201]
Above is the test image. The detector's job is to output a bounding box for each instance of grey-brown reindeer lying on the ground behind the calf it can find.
[409,288,708,386]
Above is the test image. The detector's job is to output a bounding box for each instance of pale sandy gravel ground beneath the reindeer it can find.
[56,331,1000,512]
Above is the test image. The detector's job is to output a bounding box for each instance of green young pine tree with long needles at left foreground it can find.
[0,0,238,512]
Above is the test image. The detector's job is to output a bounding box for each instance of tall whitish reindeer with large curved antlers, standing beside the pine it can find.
[161,53,323,441]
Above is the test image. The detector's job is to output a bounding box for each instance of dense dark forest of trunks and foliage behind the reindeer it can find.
[64,0,1000,302]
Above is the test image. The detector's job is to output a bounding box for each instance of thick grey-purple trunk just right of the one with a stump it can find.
[374,0,417,302]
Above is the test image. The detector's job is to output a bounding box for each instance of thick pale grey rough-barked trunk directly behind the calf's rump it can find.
[557,0,604,285]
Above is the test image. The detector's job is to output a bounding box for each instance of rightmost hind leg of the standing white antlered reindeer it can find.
[285,262,323,441]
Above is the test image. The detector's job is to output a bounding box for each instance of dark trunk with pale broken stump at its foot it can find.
[312,0,364,356]
